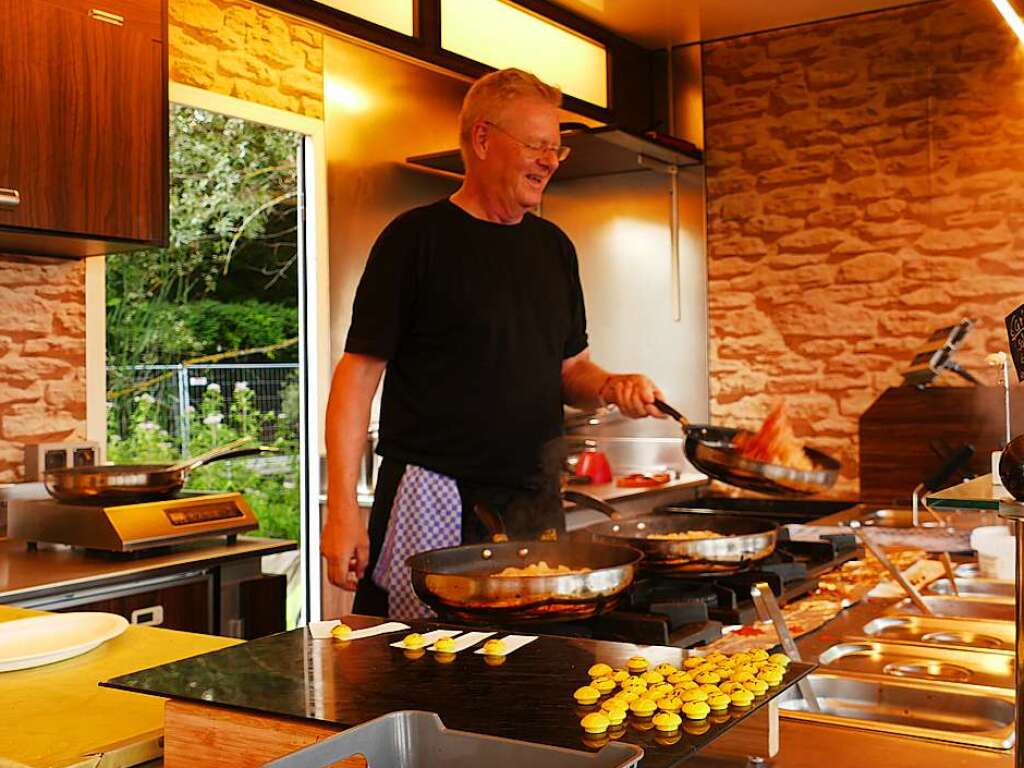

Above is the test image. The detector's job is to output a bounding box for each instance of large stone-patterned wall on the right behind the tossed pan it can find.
[703,0,1024,492]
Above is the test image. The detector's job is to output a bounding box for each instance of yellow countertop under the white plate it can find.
[0,605,241,768]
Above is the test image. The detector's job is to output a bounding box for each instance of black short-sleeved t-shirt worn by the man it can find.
[345,200,587,487]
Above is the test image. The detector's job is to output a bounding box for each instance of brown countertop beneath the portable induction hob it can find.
[0,537,298,603]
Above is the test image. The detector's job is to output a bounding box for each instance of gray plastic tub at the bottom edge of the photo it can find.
[264,710,643,768]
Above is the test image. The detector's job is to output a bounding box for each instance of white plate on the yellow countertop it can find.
[0,611,128,672]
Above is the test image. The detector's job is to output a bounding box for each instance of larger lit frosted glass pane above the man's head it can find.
[441,0,608,106]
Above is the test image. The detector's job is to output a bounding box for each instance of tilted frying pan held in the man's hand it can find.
[654,400,840,496]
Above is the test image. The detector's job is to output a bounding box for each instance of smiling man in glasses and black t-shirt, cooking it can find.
[321,70,663,616]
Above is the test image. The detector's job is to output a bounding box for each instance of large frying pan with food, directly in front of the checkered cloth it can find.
[406,541,642,624]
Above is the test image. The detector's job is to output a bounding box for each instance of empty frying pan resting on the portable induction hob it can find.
[43,437,275,504]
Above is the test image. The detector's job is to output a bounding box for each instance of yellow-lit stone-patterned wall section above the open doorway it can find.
[169,0,324,118]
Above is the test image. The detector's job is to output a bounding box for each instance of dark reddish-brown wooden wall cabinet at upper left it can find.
[0,0,168,257]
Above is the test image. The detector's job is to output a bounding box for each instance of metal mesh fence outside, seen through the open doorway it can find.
[108,362,299,457]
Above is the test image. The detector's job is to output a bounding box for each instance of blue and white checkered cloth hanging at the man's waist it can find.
[373,464,462,618]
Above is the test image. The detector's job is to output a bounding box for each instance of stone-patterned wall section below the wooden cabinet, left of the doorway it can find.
[0,256,85,482]
